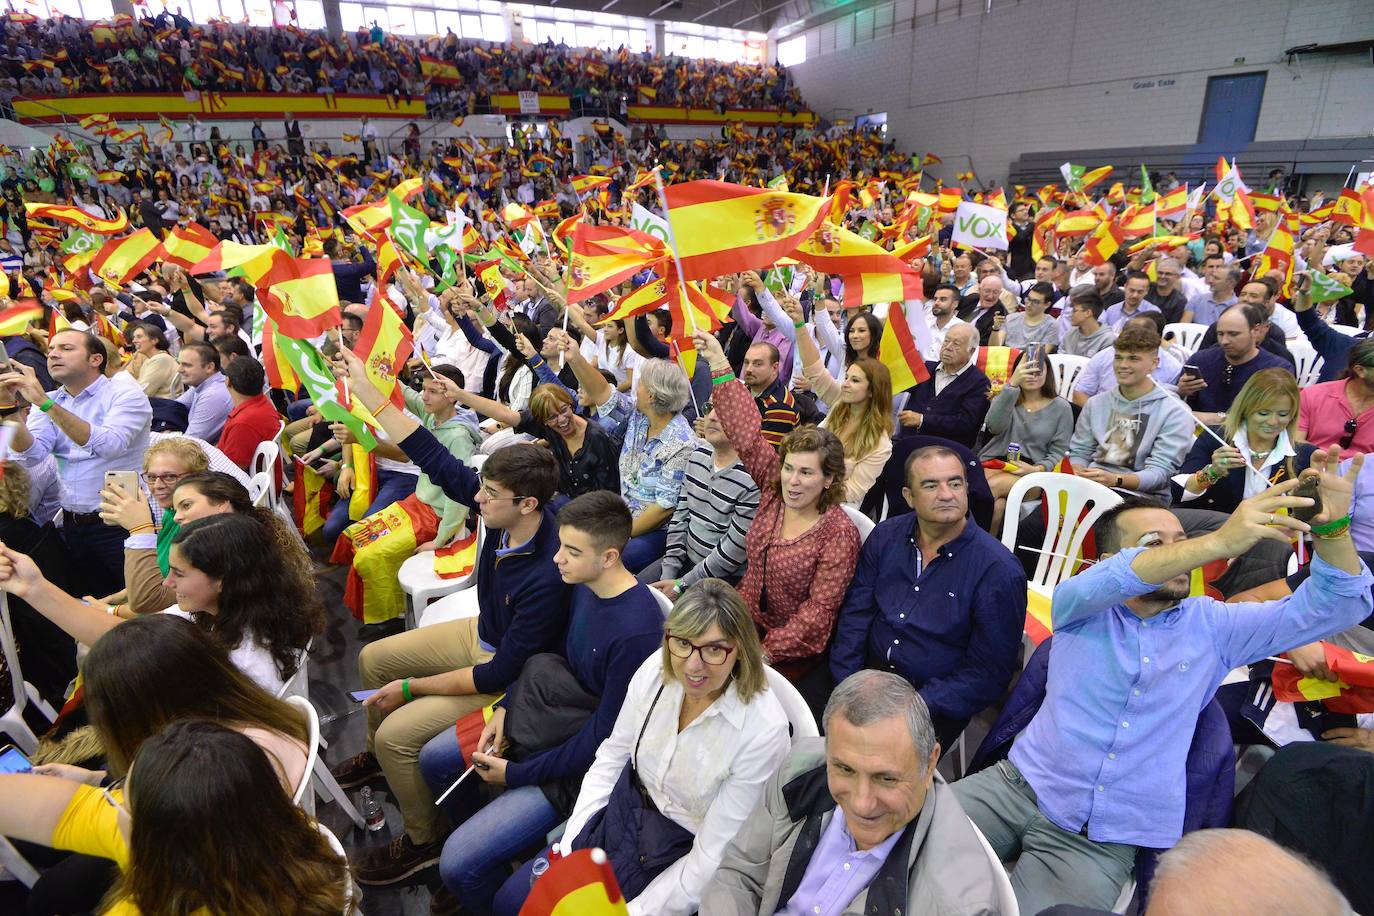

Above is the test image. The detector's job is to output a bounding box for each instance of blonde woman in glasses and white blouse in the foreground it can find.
[493,578,791,916]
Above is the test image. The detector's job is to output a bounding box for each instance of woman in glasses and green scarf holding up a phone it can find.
[88,437,210,617]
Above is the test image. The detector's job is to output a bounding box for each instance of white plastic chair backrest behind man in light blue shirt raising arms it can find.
[1002,472,1121,595]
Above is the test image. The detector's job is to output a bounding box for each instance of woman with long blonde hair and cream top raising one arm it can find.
[782,297,893,507]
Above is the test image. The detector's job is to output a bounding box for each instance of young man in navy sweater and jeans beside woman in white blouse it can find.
[420,490,664,913]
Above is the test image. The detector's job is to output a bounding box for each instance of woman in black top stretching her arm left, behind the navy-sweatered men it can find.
[436,383,620,497]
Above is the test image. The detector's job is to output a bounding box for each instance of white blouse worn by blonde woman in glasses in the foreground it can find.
[563,652,791,916]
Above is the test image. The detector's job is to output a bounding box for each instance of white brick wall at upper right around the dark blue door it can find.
[793,0,1374,181]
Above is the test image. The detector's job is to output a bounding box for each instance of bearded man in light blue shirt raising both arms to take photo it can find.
[954,449,1374,913]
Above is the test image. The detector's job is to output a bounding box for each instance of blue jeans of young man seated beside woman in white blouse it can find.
[420,728,562,915]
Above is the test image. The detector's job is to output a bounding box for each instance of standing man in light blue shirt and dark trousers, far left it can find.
[0,330,153,596]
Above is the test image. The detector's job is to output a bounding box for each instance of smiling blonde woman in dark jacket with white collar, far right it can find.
[1173,369,1316,512]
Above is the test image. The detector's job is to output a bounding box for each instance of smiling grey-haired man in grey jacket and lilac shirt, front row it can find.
[698,670,1002,916]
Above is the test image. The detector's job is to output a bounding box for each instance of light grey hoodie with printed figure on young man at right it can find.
[1069,383,1197,505]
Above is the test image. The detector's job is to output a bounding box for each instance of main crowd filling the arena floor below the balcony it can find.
[0,16,1374,916]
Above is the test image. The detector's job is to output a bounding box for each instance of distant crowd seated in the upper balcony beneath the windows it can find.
[0,8,805,115]
